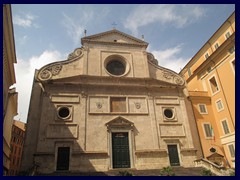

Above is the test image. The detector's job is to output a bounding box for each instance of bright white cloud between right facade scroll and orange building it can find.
[151,44,190,73]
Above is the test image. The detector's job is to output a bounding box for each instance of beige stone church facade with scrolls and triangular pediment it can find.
[21,29,201,173]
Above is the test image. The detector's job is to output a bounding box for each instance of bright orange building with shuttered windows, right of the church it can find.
[180,12,235,168]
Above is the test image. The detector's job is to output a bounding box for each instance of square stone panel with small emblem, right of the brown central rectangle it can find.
[128,97,148,114]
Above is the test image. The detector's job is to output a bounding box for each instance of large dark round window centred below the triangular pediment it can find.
[106,59,126,76]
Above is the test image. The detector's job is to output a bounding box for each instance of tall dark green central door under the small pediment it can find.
[112,133,130,168]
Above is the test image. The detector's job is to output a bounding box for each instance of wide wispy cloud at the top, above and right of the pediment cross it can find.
[124,4,205,35]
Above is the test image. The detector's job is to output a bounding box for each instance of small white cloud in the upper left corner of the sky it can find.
[13,14,39,28]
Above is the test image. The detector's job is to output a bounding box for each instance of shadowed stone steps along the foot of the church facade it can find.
[35,167,214,176]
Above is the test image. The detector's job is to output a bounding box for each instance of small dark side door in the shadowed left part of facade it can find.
[57,147,70,170]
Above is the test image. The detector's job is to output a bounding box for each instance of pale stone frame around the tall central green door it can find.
[108,129,134,169]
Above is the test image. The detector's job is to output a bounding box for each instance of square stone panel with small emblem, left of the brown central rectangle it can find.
[89,96,109,113]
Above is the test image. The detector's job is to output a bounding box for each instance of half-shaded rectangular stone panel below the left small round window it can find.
[46,124,78,139]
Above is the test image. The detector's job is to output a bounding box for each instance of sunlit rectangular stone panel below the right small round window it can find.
[159,124,186,137]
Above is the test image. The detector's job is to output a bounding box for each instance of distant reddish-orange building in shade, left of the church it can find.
[8,120,26,176]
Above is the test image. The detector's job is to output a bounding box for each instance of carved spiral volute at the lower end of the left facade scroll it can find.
[39,64,62,80]
